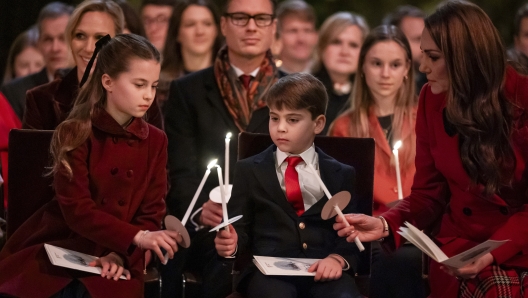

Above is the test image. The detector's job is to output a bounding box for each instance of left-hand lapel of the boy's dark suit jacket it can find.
[254,146,299,220]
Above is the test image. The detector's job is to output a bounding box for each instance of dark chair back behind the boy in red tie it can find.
[238,132,374,276]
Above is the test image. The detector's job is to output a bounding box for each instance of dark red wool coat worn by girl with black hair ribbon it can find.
[0,109,167,297]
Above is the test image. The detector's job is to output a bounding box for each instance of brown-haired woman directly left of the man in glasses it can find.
[158,0,222,105]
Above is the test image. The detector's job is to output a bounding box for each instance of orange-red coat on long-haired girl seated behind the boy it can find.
[328,109,416,215]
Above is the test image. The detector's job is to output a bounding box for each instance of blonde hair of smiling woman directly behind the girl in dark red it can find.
[65,0,125,47]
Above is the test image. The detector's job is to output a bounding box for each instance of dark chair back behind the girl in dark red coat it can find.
[6,129,54,238]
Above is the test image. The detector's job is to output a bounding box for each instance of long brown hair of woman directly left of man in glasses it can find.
[161,0,222,80]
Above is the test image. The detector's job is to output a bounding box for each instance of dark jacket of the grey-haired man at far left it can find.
[0,67,48,119]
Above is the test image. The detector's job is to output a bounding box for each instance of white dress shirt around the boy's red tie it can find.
[275,144,324,211]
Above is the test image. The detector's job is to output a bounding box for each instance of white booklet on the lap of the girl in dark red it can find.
[44,243,126,279]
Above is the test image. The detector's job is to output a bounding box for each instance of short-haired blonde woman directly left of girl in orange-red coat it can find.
[313,12,369,134]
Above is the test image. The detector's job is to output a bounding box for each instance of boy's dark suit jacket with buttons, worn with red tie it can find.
[228,145,359,284]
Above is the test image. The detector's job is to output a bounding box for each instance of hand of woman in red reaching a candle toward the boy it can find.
[334,214,389,242]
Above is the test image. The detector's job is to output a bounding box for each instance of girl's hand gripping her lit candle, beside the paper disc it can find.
[133,230,183,260]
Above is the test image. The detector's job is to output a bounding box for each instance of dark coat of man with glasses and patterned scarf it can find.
[164,67,269,218]
